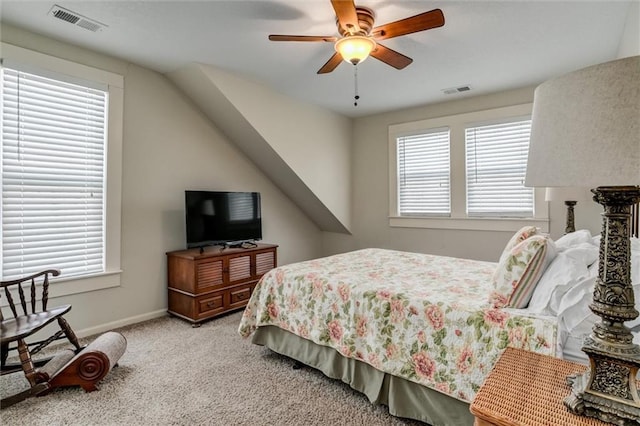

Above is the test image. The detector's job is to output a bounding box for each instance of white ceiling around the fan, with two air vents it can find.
[0,0,637,117]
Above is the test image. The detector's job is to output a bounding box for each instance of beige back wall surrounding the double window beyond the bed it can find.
[324,87,600,261]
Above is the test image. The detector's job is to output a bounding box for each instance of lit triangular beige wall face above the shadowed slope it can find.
[198,67,352,229]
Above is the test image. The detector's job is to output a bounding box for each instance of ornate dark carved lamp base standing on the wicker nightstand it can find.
[564,186,640,426]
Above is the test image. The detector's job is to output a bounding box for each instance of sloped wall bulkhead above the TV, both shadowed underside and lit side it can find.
[168,63,352,233]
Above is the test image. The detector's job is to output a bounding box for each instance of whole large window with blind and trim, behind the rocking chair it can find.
[0,43,123,297]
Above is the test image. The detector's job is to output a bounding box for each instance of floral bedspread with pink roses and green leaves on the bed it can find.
[238,249,557,402]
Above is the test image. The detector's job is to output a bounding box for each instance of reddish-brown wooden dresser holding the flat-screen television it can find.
[167,244,278,326]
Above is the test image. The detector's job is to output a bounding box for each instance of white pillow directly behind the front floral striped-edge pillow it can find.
[527,252,589,315]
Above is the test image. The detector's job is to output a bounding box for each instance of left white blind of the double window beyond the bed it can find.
[397,129,451,216]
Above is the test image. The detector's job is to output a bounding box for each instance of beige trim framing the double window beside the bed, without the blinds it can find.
[388,103,549,232]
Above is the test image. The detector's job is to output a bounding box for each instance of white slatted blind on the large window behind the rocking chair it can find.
[0,68,108,279]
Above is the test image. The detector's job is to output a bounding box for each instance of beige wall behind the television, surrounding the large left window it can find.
[2,26,321,334]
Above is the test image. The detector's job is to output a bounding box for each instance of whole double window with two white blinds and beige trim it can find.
[389,104,548,231]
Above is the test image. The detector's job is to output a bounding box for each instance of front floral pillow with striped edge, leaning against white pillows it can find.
[491,235,557,308]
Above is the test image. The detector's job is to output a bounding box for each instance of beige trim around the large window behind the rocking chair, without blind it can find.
[0,42,124,297]
